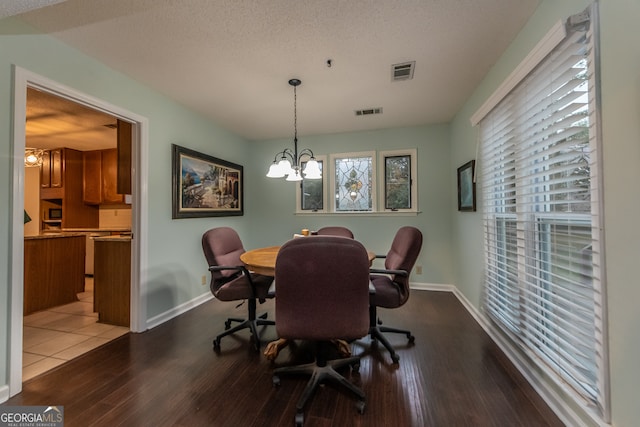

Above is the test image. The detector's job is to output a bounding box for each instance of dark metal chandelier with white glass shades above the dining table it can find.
[267,79,322,181]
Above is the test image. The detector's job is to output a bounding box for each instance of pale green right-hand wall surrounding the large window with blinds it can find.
[451,0,640,426]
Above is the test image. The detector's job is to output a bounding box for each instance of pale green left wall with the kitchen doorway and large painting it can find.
[0,18,253,391]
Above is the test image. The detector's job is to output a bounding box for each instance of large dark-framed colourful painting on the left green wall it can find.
[171,144,244,219]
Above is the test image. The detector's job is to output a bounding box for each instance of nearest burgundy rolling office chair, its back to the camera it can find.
[273,236,369,425]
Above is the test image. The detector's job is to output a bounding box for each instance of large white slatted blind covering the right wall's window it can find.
[480,5,608,418]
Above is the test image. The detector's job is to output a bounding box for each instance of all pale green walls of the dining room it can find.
[5,0,640,426]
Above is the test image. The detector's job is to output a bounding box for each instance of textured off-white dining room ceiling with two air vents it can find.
[19,0,538,145]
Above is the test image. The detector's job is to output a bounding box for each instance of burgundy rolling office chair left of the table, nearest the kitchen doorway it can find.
[202,227,275,350]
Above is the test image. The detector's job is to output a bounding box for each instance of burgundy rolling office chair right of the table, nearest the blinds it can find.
[369,227,422,363]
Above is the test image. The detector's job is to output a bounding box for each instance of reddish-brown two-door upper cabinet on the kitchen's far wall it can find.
[83,148,124,205]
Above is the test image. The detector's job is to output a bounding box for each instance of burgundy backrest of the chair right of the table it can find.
[384,226,422,304]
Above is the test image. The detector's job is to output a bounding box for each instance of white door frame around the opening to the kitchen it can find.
[9,65,149,396]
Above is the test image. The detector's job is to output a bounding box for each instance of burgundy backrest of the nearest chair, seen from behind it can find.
[275,236,369,341]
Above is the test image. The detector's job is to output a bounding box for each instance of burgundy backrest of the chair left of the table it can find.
[202,227,245,283]
